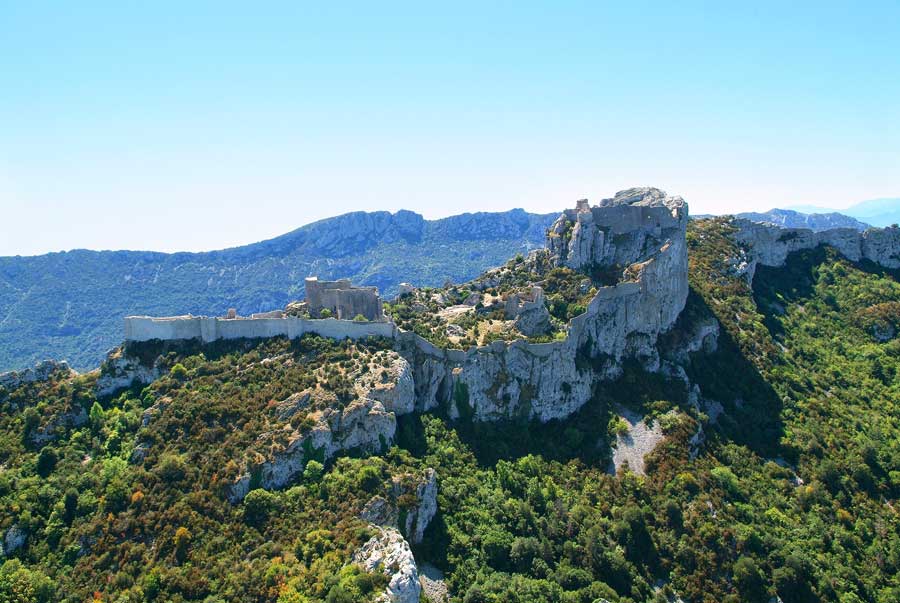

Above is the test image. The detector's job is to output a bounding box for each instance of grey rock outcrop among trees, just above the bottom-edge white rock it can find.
[360,469,437,544]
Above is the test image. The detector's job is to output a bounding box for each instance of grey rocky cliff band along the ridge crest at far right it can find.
[732,219,900,281]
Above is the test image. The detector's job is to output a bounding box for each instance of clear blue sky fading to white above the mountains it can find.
[0,0,900,255]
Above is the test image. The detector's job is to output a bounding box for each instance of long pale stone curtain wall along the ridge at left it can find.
[125,316,394,342]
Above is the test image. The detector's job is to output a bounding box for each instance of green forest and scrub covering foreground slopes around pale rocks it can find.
[0,218,900,603]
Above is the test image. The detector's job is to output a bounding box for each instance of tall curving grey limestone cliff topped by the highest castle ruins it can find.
[399,189,688,421]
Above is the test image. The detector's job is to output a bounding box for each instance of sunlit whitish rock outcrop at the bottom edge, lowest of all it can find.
[353,526,422,603]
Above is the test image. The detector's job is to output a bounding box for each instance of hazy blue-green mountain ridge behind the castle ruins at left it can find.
[0,209,556,370]
